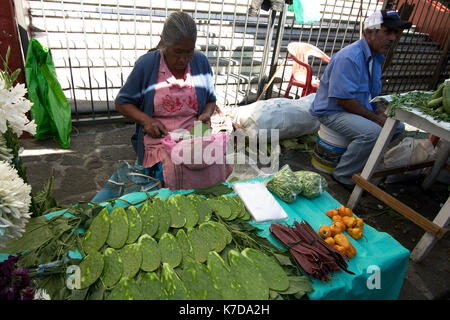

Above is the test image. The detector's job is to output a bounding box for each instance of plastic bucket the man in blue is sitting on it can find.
[311,124,349,173]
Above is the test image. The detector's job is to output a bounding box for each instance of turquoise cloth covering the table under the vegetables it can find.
[0,178,410,300]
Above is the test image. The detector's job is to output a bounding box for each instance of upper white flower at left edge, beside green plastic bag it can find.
[0,83,36,136]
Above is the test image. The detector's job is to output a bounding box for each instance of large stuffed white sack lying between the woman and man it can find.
[233,93,320,140]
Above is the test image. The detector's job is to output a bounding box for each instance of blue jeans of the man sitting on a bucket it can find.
[319,112,405,185]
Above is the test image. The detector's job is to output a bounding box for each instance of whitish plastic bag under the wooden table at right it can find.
[383,137,434,183]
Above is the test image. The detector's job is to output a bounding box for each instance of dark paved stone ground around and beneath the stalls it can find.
[21,123,450,300]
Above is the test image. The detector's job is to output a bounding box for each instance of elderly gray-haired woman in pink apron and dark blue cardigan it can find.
[115,12,229,189]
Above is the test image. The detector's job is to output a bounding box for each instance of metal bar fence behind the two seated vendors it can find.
[18,0,450,122]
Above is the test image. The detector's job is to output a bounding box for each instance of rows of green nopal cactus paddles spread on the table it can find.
[34,194,310,300]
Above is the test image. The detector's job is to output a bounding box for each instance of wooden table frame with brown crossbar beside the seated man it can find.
[347,102,450,262]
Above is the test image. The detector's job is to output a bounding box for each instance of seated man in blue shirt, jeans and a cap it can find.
[310,10,411,188]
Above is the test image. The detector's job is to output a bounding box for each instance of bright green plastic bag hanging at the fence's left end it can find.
[25,39,72,149]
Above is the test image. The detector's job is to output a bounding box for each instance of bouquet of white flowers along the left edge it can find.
[0,48,36,248]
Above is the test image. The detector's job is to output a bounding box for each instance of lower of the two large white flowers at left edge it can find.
[0,161,31,247]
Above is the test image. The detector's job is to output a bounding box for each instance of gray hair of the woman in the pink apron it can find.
[161,11,197,46]
